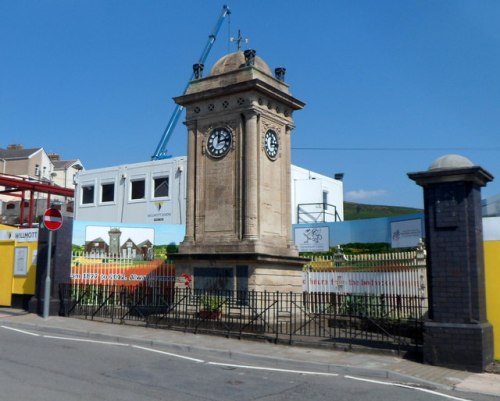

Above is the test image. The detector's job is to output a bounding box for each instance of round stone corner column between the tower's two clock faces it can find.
[243,110,259,240]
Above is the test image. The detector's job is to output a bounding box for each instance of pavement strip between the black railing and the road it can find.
[0,308,500,397]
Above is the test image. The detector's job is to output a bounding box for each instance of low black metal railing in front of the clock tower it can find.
[60,284,426,351]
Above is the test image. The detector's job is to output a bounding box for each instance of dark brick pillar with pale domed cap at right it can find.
[408,155,493,372]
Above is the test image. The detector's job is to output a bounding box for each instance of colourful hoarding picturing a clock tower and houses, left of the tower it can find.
[71,221,184,288]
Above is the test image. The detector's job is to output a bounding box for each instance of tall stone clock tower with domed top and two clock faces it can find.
[171,50,305,291]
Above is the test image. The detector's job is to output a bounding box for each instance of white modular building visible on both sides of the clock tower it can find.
[75,156,344,224]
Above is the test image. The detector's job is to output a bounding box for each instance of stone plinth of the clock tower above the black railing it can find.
[171,253,309,292]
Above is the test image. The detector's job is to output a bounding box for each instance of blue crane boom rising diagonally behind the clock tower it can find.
[151,5,231,160]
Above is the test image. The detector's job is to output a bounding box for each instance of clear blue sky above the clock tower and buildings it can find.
[0,0,500,207]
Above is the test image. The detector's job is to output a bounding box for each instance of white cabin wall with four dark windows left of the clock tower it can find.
[75,157,187,224]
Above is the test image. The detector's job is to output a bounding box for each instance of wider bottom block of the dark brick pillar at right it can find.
[423,321,493,372]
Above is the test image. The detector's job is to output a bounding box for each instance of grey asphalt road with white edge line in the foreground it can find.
[0,326,498,401]
